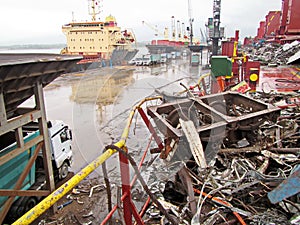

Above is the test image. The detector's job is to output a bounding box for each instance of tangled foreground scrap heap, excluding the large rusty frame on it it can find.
[141,92,300,225]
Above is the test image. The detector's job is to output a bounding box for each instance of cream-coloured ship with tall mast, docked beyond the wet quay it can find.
[61,0,138,70]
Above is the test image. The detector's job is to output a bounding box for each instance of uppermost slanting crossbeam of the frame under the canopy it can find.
[0,109,41,136]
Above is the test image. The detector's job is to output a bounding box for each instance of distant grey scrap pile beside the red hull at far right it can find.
[250,41,300,65]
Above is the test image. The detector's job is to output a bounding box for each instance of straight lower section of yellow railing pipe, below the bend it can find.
[13,149,115,225]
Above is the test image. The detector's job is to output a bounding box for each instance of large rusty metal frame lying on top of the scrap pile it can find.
[147,92,280,164]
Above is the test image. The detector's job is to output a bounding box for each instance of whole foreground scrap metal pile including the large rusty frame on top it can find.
[139,92,300,225]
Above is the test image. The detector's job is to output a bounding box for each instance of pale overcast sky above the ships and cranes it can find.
[0,0,281,45]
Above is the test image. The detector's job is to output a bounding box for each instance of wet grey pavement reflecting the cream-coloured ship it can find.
[39,58,207,174]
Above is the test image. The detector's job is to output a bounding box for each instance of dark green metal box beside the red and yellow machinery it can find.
[211,56,232,77]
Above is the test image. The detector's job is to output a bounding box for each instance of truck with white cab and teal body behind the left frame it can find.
[0,120,73,221]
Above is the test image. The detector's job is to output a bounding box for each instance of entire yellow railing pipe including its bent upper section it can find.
[13,96,162,225]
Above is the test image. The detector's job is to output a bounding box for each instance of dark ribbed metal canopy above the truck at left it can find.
[0,53,82,119]
